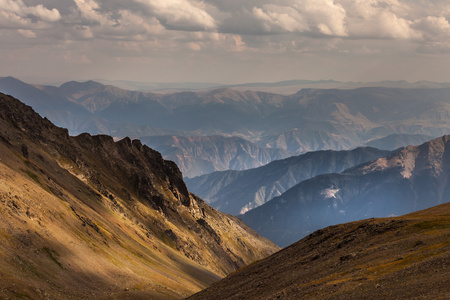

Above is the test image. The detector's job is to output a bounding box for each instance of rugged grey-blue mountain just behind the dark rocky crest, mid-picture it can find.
[140,136,290,177]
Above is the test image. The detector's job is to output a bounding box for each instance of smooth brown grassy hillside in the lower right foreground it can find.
[188,204,450,300]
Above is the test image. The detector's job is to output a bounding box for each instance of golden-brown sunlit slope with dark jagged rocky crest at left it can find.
[0,94,278,299]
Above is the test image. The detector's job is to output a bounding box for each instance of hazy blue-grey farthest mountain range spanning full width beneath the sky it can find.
[0,77,450,174]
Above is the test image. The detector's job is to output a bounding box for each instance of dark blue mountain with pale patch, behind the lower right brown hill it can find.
[242,136,450,246]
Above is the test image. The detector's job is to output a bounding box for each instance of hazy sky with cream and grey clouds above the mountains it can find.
[0,0,450,84]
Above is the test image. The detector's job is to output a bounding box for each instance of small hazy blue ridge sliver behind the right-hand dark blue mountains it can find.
[366,134,435,150]
